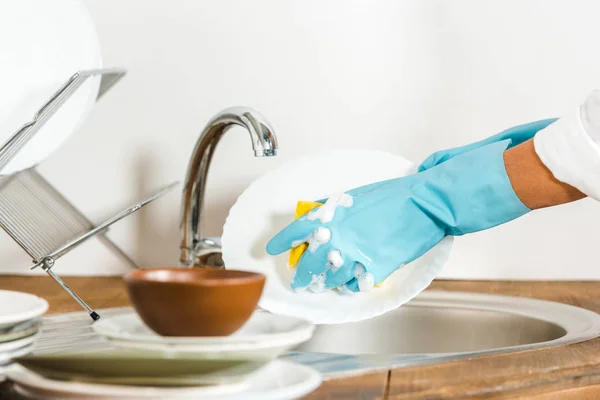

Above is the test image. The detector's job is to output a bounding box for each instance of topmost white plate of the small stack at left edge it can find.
[0,290,48,328]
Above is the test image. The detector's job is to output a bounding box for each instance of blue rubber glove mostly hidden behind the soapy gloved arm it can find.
[419,118,557,172]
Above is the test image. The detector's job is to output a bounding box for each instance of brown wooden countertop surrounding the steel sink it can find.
[0,276,600,400]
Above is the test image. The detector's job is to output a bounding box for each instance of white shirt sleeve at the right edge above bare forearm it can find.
[533,90,600,200]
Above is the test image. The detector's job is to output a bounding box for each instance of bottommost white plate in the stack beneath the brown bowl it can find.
[6,360,321,400]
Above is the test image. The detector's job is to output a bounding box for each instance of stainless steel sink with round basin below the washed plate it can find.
[289,291,600,377]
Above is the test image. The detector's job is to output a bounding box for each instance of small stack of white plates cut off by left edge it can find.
[0,290,48,380]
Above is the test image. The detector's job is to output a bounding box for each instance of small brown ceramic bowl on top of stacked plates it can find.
[125,268,265,336]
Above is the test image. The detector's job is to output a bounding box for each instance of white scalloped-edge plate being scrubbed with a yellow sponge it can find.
[222,150,453,324]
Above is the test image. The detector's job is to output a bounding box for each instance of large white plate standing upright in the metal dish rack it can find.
[0,0,102,175]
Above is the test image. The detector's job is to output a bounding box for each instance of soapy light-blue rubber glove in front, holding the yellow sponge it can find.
[267,139,530,292]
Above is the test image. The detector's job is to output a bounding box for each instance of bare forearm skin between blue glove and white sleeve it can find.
[504,139,586,210]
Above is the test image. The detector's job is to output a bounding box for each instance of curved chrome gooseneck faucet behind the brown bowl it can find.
[179,107,277,266]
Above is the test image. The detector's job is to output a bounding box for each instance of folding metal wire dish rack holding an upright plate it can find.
[0,68,178,320]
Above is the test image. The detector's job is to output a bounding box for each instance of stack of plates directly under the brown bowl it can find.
[7,311,321,400]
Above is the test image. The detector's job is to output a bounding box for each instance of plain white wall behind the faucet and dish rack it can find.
[1,0,600,279]
